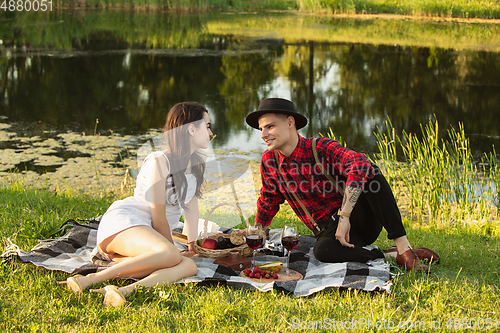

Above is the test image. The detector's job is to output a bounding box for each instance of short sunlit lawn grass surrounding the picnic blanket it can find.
[0,124,500,332]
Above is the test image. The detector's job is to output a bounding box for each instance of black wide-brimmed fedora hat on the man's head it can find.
[245,98,307,129]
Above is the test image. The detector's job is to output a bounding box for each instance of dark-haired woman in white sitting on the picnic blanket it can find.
[59,102,212,306]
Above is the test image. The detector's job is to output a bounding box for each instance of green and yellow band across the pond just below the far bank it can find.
[5,10,500,52]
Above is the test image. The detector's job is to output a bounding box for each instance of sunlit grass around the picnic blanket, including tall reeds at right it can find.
[0,118,500,332]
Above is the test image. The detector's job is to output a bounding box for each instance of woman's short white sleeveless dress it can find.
[97,152,197,244]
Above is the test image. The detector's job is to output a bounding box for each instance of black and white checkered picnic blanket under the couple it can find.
[3,218,391,296]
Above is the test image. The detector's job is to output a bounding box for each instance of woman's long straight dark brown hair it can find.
[164,102,208,209]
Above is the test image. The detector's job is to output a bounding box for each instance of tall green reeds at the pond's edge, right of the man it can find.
[374,120,500,235]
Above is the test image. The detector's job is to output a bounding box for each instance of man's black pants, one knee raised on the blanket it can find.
[314,168,406,263]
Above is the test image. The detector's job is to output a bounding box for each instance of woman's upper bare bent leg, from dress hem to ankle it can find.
[78,226,182,289]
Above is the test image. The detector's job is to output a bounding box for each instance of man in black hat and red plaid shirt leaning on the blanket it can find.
[246,98,439,272]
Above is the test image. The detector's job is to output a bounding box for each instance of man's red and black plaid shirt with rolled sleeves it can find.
[255,135,375,230]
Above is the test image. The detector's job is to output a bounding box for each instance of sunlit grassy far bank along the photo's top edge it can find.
[46,0,500,23]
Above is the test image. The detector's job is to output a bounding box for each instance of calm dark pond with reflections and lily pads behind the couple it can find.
[0,10,500,178]
